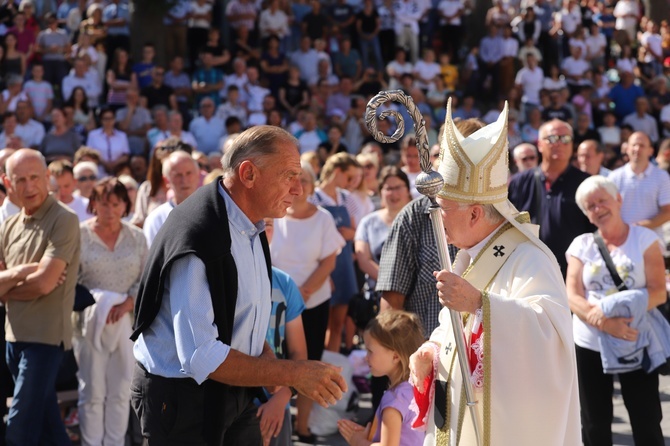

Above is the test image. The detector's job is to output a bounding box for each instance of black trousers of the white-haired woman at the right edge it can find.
[576,346,665,446]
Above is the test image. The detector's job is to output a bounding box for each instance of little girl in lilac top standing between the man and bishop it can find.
[338,310,424,446]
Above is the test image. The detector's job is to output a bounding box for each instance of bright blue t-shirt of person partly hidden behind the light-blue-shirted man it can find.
[265,266,305,359]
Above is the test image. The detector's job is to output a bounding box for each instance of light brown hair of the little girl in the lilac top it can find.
[365,310,425,387]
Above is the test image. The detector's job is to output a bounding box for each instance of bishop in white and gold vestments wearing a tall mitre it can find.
[411,103,581,446]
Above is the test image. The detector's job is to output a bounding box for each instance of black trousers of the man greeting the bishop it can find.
[131,363,262,446]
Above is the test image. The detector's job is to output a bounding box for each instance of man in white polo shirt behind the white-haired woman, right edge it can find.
[608,132,670,240]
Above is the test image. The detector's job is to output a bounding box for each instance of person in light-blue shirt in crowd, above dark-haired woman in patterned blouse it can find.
[86,108,130,174]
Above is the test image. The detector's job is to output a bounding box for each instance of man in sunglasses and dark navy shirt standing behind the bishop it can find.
[509,119,592,276]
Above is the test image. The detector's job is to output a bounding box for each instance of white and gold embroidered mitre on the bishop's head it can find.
[437,98,509,204]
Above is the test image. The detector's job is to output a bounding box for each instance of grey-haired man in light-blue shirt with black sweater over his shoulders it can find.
[131,126,346,446]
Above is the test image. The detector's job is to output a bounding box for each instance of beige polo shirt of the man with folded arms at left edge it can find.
[0,196,80,350]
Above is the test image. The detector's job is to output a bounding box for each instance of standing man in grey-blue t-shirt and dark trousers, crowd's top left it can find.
[37,12,70,85]
